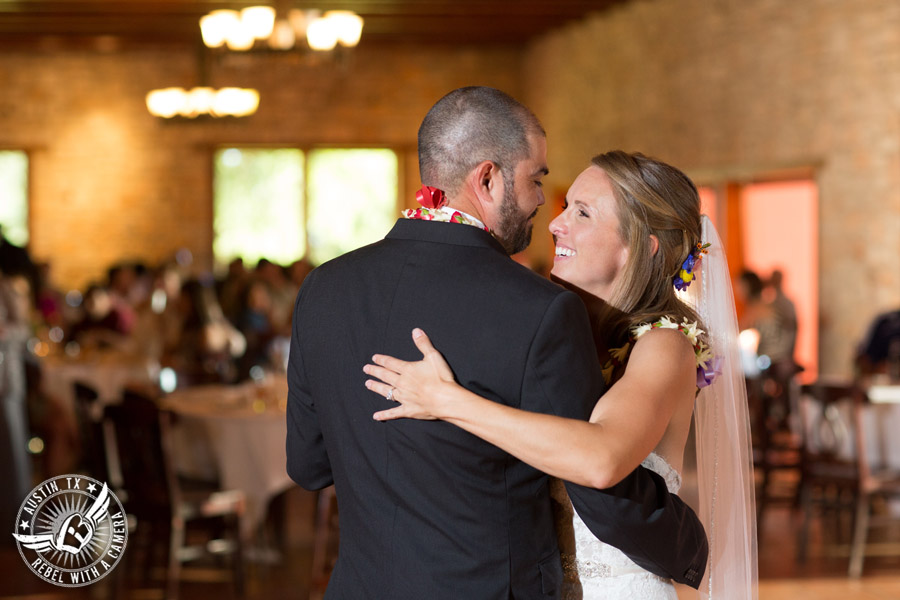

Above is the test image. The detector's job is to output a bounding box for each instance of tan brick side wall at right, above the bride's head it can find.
[523,0,900,374]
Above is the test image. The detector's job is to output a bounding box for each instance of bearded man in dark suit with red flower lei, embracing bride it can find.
[287,87,707,600]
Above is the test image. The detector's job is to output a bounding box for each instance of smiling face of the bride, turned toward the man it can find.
[550,166,628,300]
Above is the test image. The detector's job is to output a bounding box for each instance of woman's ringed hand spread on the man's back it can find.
[363,329,458,421]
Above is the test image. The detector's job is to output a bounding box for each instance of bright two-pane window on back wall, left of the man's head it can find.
[213,148,398,265]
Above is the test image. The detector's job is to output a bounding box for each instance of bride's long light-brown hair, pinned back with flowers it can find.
[591,150,702,343]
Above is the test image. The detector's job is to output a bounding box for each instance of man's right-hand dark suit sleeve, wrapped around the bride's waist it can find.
[522,292,709,588]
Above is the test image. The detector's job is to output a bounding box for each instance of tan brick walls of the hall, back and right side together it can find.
[0,0,900,373]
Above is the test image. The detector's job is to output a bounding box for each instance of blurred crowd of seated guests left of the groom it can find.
[7,246,311,383]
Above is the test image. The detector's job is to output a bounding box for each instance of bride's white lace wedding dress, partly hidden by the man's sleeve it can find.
[551,453,681,600]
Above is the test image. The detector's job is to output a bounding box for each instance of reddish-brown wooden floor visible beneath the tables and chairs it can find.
[0,489,900,600]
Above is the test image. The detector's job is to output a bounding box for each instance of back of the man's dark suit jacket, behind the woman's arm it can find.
[288,221,599,599]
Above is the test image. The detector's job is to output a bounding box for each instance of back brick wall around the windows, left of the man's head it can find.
[0,44,520,287]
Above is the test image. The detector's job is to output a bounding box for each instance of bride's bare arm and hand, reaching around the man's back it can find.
[364,329,696,489]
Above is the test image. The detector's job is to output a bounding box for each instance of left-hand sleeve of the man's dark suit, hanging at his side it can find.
[286,271,334,490]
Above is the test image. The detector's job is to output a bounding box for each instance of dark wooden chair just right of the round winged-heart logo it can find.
[106,391,245,600]
